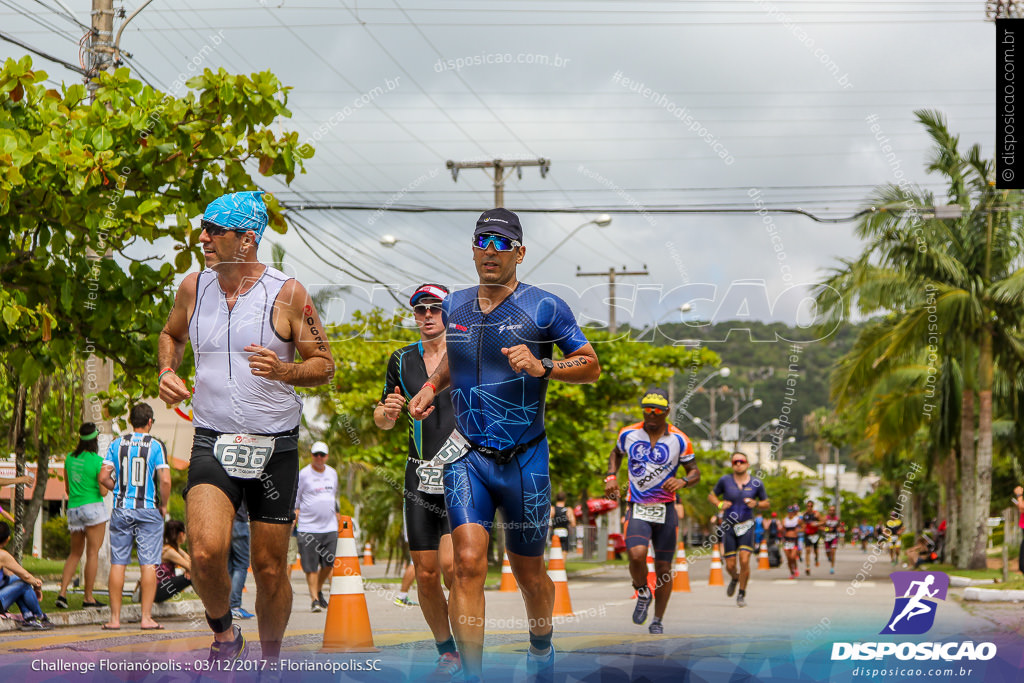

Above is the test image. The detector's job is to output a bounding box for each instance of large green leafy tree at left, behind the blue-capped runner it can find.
[0,57,311,551]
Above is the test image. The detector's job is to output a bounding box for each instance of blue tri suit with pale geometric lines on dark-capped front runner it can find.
[441,283,588,557]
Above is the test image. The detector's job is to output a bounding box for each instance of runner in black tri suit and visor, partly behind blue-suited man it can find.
[374,283,462,680]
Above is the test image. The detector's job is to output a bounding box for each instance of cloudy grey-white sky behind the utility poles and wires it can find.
[0,0,994,326]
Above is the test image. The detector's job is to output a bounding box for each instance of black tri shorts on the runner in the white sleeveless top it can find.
[182,427,299,524]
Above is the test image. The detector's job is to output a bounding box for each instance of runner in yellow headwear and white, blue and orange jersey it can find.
[604,389,700,635]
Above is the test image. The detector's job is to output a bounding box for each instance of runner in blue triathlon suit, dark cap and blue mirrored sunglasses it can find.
[409,209,601,681]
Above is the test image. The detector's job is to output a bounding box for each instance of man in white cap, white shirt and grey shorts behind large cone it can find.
[295,441,338,612]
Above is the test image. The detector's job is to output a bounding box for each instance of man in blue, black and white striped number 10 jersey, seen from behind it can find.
[98,403,171,631]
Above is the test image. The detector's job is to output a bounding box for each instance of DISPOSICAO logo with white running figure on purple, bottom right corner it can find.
[831,571,996,661]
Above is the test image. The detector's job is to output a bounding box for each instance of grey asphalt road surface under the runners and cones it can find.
[0,547,1019,683]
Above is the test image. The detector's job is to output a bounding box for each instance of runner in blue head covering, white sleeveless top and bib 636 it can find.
[160,193,334,659]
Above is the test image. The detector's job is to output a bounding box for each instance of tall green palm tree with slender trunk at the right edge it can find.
[817,111,1024,568]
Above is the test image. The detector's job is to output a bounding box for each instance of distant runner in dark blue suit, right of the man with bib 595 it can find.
[708,451,768,607]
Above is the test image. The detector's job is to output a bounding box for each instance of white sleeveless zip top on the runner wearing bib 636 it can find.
[188,266,302,434]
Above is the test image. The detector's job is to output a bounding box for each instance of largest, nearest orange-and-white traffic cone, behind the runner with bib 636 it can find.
[321,516,379,652]
